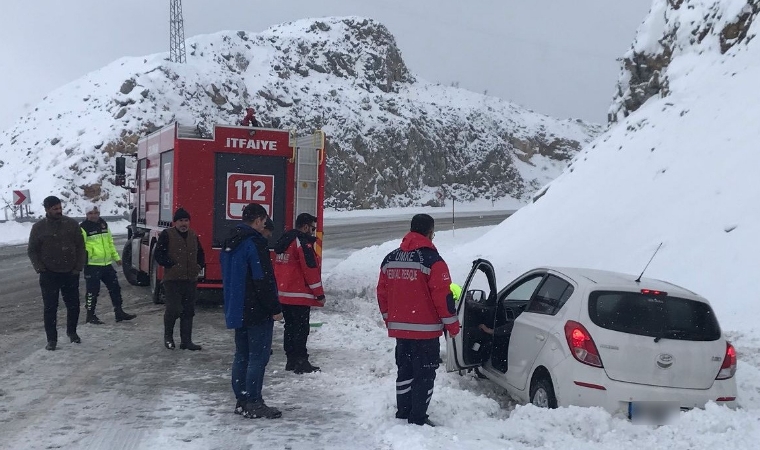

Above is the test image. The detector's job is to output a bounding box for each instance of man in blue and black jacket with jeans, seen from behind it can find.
[220,203,282,419]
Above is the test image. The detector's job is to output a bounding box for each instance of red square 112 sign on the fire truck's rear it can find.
[227,173,274,220]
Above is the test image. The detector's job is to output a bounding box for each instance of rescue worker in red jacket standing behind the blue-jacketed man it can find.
[274,213,325,374]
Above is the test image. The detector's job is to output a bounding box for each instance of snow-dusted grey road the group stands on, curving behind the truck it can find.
[0,213,508,450]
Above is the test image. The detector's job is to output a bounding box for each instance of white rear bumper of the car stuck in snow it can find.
[552,357,737,417]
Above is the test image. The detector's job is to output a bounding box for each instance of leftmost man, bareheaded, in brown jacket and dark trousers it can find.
[27,195,87,350]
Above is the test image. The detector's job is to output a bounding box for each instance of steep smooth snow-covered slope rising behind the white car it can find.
[464,0,760,330]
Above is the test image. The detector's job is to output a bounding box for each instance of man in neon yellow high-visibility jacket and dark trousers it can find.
[79,205,137,325]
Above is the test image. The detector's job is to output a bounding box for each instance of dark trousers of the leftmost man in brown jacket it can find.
[40,272,79,342]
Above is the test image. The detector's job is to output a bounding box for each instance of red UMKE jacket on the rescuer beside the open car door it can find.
[377,232,459,339]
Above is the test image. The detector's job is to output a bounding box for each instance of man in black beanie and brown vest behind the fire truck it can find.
[154,208,206,350]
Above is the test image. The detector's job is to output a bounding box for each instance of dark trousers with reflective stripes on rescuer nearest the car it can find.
[396,338,440,425]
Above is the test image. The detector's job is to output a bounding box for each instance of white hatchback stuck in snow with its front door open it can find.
[446,259,736,420]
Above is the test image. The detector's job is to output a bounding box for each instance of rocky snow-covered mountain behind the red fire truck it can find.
[0,17,600,214]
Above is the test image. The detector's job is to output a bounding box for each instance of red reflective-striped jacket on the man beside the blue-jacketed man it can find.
[274,230,325,306]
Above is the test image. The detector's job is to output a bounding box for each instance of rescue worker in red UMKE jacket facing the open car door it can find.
[377,214,459,426]
